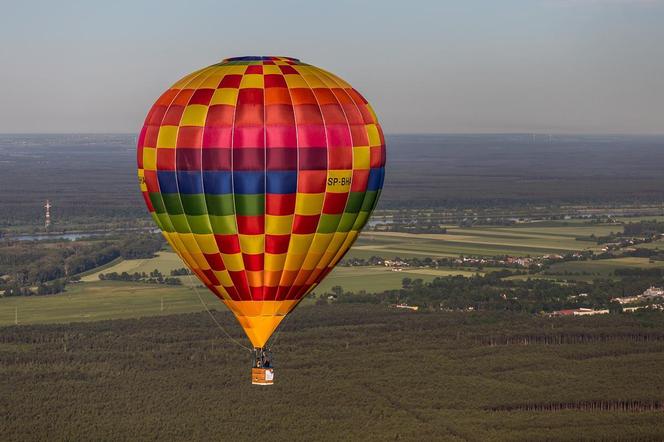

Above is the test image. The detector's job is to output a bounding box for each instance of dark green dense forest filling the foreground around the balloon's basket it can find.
[0,305,664,441]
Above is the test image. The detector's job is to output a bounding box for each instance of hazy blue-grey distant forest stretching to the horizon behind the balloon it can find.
[0,134,664,233]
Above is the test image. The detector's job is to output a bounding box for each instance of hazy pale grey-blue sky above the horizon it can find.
[0,0,664,133]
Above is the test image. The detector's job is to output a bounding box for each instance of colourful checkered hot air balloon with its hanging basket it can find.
[138,56,385,384]
